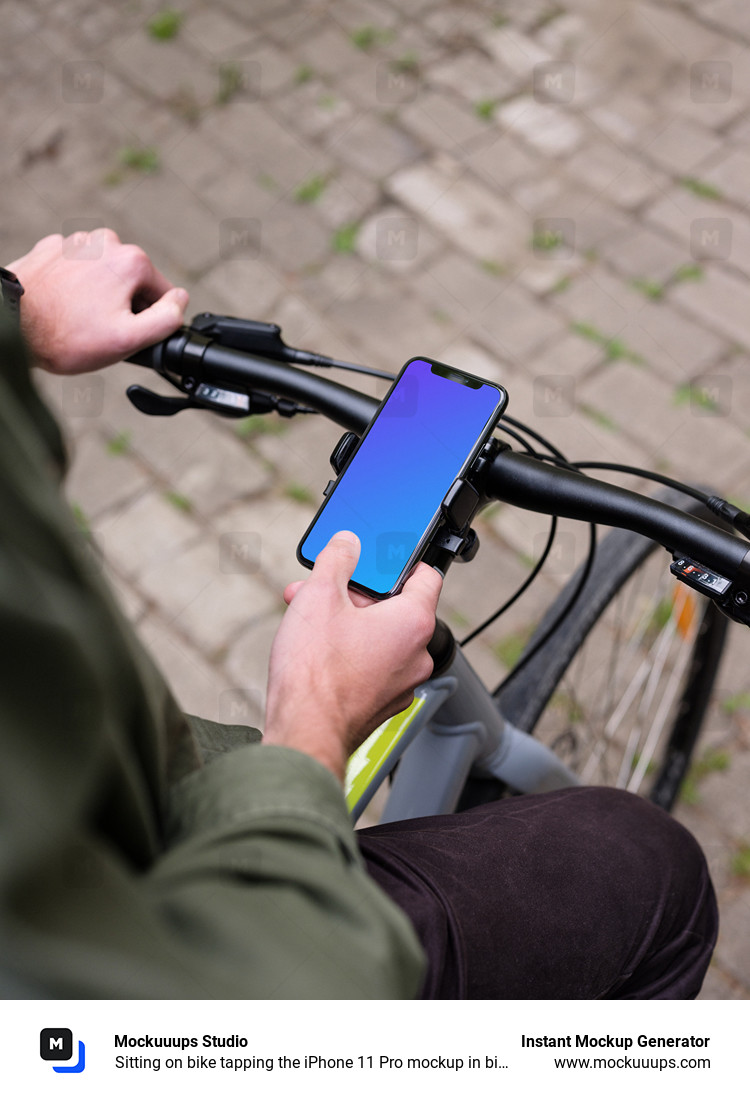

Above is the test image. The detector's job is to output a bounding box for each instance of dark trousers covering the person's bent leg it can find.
[357,788,718,999]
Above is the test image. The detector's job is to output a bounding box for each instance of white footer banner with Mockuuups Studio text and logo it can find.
[10,1001,750,1100]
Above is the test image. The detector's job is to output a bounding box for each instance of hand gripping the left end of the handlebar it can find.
[8,229,188,374]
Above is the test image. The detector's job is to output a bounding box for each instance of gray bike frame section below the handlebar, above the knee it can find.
[352,648,581,822]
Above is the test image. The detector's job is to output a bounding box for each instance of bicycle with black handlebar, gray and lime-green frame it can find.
[128,314,750,822]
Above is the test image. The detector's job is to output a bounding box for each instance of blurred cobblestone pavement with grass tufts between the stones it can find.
[0,0,750,999]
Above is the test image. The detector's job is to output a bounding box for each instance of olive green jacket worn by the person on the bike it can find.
[0,323,423,999]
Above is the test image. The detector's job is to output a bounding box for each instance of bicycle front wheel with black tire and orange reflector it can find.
[495,492,728,810]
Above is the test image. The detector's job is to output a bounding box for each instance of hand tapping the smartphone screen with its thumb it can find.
[264,531,442,779]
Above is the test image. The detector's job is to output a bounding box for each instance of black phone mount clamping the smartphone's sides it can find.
[323,431,508,573]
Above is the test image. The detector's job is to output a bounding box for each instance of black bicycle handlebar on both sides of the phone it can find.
[129,328,750,607]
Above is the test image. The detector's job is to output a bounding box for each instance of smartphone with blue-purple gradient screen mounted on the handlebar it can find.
[297,359,508,600]
